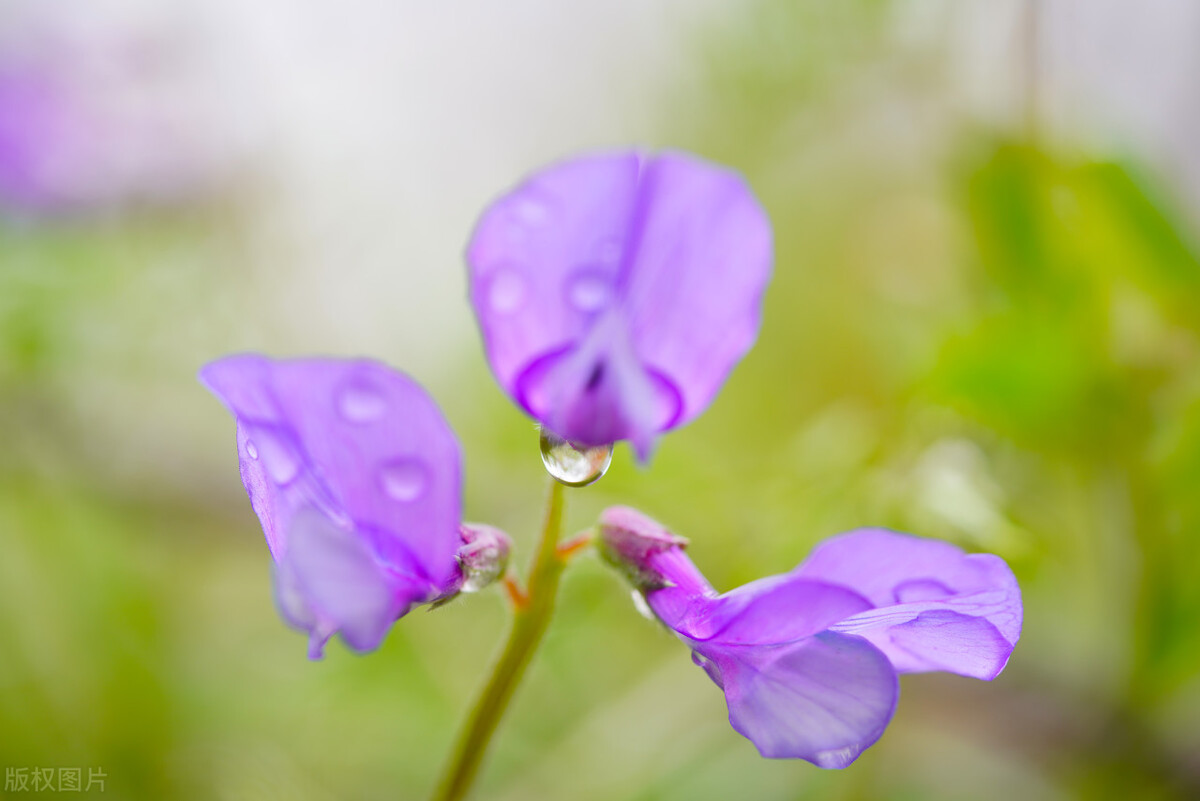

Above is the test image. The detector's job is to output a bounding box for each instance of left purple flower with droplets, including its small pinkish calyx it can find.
[200,355,480,660]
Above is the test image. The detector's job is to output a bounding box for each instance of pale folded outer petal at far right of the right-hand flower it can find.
[793,529,1022,679]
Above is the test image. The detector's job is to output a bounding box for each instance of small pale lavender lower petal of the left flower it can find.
[275,510,428,660]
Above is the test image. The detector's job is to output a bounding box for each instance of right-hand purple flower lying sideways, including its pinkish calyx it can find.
[601,507,1022,767]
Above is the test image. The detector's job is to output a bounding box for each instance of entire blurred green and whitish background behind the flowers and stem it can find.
[0,0,1200,801]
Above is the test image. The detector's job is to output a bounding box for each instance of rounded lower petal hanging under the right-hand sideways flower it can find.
[696,633,900,767]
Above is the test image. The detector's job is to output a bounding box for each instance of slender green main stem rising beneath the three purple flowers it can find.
[433,481,566,801]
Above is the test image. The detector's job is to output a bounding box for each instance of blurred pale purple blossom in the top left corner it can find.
[0,2,244,215]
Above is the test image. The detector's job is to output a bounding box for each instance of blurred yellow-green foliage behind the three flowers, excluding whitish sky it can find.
[0,0,1200,801]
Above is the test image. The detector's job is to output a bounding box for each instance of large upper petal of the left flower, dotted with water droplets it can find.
[200,355,461,586]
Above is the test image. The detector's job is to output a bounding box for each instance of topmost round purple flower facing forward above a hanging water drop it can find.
[467,150,772,460]
